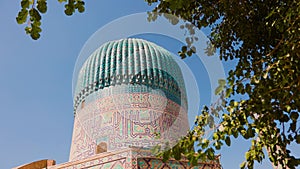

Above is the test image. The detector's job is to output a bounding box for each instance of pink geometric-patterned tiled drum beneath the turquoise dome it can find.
[70,91,189,161]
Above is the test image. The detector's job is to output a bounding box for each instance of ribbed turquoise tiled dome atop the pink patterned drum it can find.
[74,38,185,112]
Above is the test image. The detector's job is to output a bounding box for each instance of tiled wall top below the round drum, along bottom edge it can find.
[48,148,222,169]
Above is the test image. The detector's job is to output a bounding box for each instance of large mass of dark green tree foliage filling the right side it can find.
[147,0,300,168]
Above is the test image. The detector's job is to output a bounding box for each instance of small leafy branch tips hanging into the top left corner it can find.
[16,0,85,40]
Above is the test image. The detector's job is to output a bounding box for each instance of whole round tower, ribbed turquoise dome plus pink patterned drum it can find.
[70,39,189,164]
